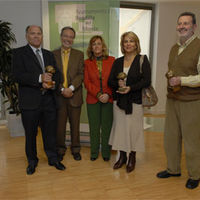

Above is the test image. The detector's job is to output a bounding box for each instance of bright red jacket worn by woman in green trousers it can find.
[84,56,115,104]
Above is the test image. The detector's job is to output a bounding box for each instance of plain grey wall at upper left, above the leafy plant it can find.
[0,0,42,47]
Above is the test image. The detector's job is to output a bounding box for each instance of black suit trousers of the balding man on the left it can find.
[21,95,57,165]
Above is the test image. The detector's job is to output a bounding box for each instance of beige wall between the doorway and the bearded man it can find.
[152,1,200,113]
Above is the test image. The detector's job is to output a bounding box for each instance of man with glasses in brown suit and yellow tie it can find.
[53,27,84,160]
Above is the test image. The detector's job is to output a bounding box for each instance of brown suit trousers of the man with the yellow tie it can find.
[57,97,81,155]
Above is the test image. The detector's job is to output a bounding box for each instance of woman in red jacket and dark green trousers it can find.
[84,35,115,161]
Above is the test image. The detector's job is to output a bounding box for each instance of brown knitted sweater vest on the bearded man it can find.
[167,38,200,101]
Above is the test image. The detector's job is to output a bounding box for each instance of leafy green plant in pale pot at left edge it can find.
[0,20,24,136]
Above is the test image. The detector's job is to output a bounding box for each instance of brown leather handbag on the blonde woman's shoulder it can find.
[140,55,158,107]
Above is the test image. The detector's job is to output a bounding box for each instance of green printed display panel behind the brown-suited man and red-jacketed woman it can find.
[48,0,120,123]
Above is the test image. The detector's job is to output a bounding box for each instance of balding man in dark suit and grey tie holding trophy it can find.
[13,25,65,175]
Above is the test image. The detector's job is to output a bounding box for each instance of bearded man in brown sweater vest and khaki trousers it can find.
[157,12,200,189]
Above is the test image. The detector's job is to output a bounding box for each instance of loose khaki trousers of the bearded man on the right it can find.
[164,99,200,180]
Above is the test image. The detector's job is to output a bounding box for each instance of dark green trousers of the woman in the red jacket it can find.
[87,102,113,158]
